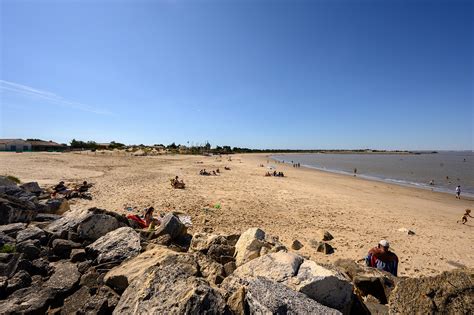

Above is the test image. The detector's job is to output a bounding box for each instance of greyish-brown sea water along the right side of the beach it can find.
[272,151,474,197]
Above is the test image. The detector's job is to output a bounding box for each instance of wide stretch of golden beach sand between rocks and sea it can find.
[0,153,474,277]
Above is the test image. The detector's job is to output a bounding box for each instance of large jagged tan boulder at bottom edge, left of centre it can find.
[114,254,226,314]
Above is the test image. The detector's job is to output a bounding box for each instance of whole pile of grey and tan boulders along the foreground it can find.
[0,178,474,314]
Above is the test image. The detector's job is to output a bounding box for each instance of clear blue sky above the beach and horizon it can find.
[0,0,474,150]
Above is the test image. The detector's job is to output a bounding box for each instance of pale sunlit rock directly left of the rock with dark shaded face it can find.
[234,252,303,282]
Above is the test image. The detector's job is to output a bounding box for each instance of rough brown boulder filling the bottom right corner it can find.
[389,268,474,314]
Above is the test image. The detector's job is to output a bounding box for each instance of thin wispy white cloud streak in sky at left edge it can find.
[0,80,112,115]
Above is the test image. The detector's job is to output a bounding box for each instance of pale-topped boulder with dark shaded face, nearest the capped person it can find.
[287,260,353,313]
